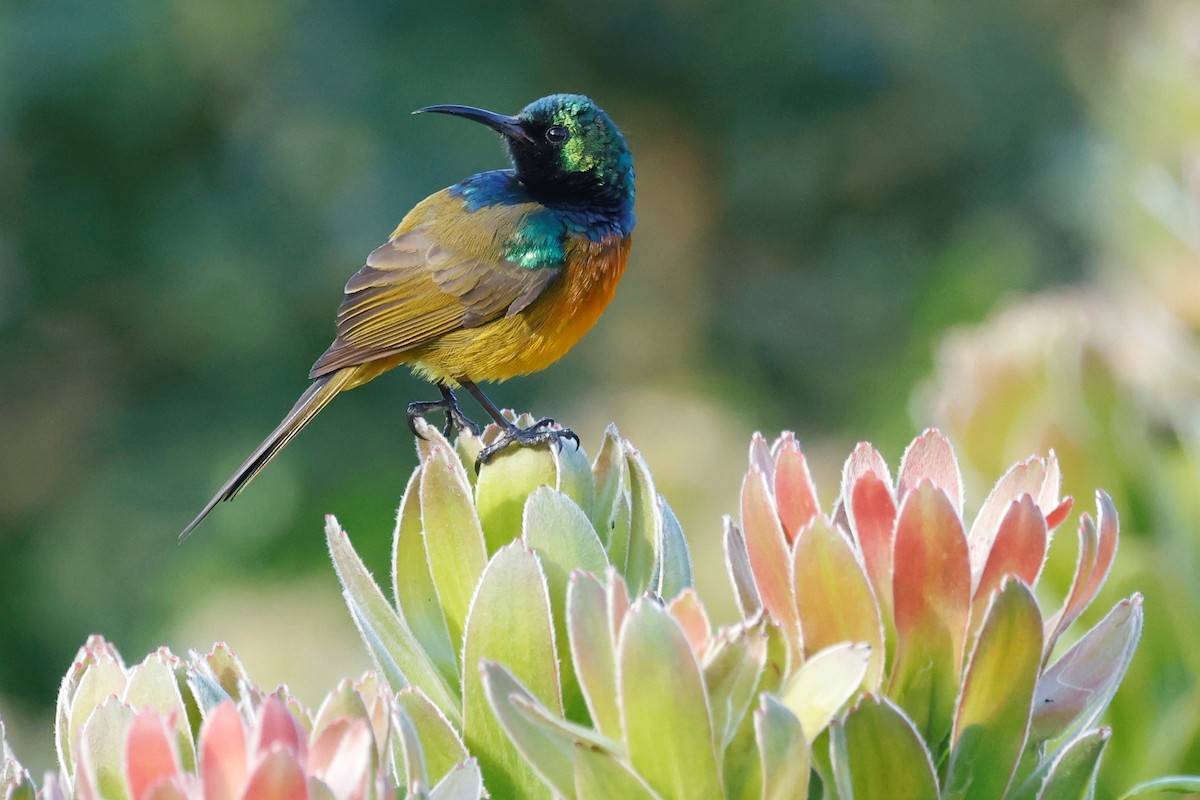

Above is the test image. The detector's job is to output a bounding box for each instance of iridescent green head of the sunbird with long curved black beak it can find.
[420,95,634,204]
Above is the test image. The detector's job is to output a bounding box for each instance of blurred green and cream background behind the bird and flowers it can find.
[0,0,1200,798]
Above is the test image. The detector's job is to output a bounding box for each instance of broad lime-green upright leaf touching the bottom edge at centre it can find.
[617,600,722,800]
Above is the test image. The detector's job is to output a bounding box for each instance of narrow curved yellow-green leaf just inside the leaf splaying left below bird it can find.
[391,469,460,691]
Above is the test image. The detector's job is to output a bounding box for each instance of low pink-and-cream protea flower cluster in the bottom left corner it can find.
[25,637,481,800]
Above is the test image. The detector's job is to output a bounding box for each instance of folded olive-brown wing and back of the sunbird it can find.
[310,196,562,378]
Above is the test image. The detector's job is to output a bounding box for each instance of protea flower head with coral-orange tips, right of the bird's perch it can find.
[726,431,1142,800]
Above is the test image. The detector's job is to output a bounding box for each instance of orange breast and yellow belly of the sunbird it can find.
[404,236,630,383]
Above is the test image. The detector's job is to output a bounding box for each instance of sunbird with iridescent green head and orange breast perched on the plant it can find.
[179,94,636,541]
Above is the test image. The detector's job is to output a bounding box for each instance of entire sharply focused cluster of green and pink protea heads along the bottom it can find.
[0,420,1200,800]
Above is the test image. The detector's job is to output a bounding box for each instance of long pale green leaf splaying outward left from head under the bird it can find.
[325,516,462,722]
